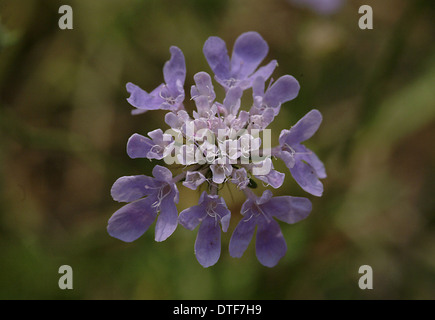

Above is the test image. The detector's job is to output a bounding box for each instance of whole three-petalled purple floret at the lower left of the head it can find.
[107,165,178,242]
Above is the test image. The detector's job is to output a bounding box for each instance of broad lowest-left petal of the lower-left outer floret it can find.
[107,196,157,242]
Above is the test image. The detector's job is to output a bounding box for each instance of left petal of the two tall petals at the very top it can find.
[203,37,230,79]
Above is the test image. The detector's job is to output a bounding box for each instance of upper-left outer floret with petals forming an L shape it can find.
[127,46,186,114]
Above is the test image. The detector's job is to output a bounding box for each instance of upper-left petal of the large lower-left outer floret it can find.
[110,175,155,202]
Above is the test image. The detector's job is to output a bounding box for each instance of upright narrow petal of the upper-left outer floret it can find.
[163,46,186,94]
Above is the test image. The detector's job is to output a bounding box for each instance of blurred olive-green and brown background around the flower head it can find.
[0,0,435,299]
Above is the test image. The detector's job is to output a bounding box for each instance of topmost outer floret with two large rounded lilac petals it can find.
[203,31,277,90]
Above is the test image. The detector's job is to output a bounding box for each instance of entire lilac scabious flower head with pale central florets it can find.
[107,32,326,267]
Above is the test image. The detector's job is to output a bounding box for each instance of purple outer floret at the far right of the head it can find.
[274,110,326,197]
